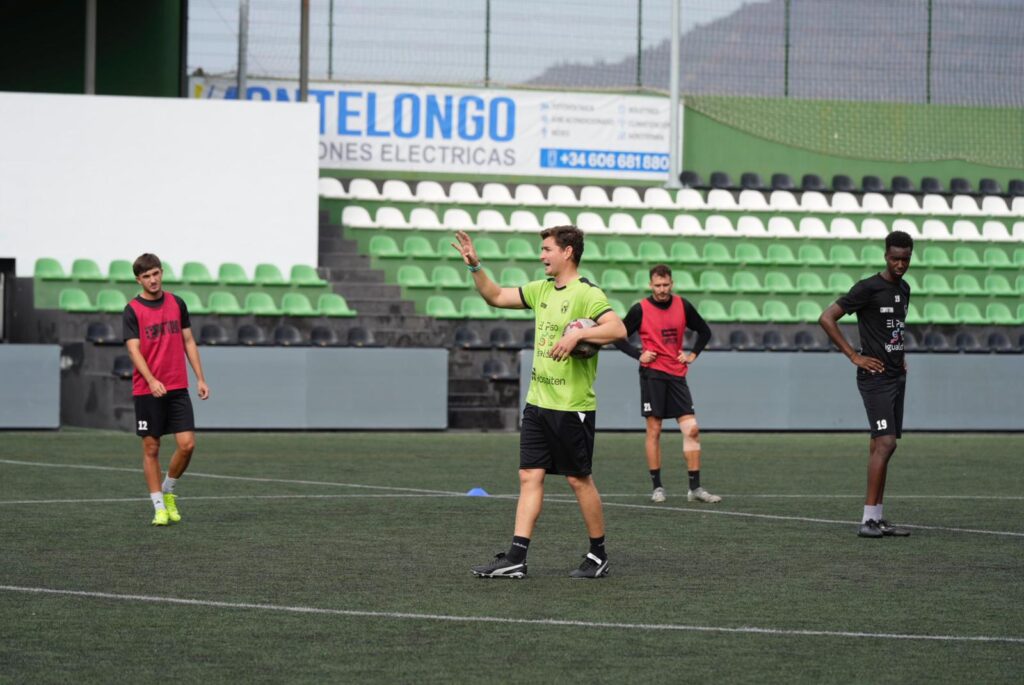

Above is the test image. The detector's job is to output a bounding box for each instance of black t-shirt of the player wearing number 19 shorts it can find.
[836,273,910,376]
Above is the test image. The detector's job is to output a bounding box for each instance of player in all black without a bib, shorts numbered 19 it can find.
[818,230,913,538]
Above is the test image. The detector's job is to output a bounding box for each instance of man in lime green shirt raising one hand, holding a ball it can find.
[452,226,626,579]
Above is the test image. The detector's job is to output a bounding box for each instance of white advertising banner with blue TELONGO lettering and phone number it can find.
[189,77,670,180]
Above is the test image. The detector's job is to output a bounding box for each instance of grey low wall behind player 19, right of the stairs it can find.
[519,350,1024,431]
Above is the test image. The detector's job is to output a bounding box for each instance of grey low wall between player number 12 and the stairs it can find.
[191,347,449,430]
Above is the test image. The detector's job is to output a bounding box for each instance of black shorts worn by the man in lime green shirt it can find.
[519,404,597,476]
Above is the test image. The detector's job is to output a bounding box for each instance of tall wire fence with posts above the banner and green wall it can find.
[188,0,1024,106]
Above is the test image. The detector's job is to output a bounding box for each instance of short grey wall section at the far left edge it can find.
[0,345,60,428]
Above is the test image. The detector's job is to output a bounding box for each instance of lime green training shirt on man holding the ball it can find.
[519,279,611,412]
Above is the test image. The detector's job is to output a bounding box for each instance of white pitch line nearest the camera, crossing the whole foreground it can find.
[0,585,1024,644]
